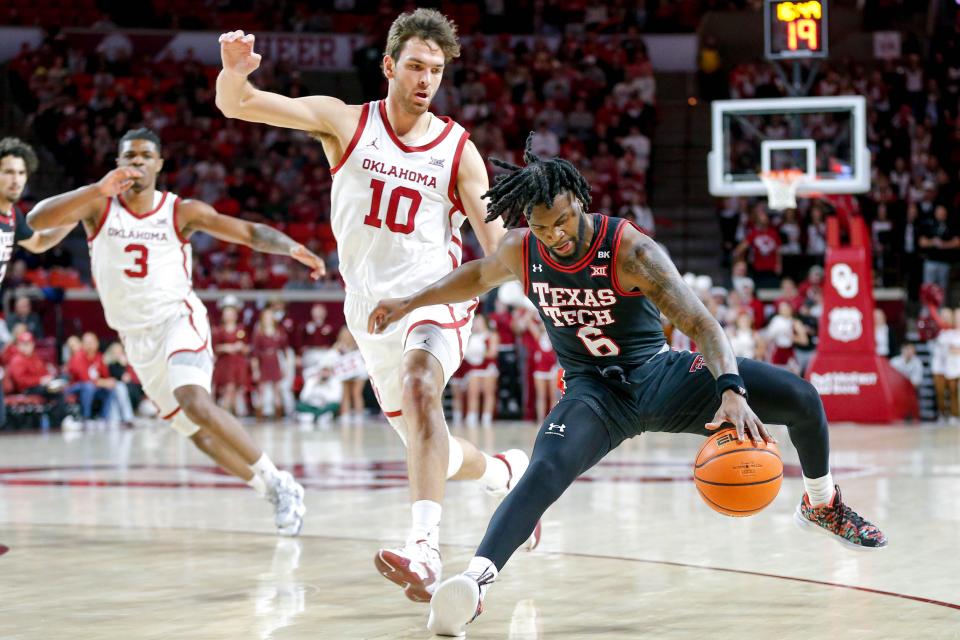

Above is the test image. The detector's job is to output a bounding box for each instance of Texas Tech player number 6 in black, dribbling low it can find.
[369,139,887,635]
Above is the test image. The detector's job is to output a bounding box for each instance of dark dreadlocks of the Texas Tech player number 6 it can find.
[482,131,590,227]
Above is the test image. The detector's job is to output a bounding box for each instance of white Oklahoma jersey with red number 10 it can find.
[331,101,469,300]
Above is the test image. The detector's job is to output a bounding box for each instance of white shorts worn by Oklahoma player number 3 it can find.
[120,299,213,420]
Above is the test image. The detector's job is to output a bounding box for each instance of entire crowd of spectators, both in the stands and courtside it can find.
[0,0,960,425]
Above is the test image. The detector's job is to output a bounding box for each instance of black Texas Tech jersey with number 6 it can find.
[523,214,666,373]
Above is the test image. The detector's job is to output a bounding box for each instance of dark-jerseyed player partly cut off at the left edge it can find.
[0,138,76,427]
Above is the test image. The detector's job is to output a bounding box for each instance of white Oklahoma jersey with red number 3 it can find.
[88,191,202,332]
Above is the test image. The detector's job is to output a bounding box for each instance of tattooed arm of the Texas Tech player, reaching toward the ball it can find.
[623,239,737,378]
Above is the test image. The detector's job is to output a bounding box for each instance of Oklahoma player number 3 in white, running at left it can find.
[27,129,324,535]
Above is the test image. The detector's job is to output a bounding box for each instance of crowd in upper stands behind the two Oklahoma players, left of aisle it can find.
[8,12,656,288]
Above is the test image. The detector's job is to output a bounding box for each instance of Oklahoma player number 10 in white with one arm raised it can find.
[217,9,539,602]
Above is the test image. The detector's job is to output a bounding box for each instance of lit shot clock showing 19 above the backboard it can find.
[763,0,827,60]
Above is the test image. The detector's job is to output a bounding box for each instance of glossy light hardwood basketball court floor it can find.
[0,421,960,640]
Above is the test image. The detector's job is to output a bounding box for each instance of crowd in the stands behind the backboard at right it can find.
[719,31,960,300]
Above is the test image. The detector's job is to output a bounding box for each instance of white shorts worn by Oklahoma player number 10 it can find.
[343,293,479,418]
